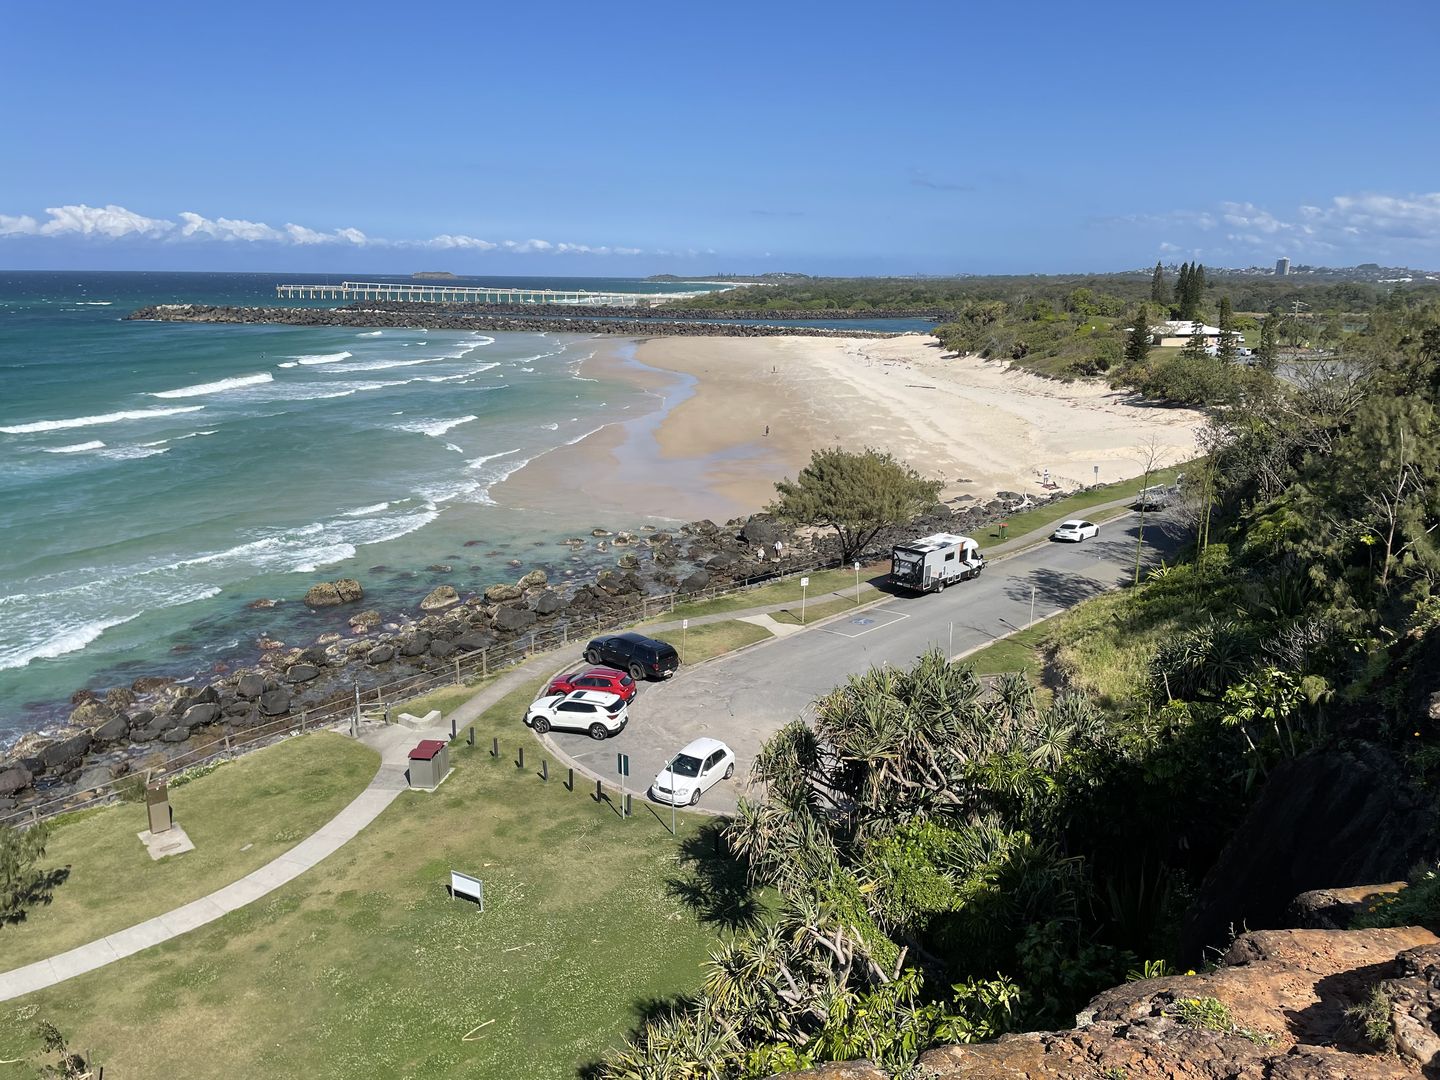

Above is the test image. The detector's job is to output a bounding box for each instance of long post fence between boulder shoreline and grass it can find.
[0,559,840,828]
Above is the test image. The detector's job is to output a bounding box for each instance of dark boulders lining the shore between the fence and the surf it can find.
[0,483,1082,815]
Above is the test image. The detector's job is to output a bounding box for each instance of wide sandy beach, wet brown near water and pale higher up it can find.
[495,334,1202,520]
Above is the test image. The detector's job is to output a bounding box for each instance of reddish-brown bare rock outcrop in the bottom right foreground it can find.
[791,927,1440,1080]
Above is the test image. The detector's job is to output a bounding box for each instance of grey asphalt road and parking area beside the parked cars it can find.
[550,513,1181,812]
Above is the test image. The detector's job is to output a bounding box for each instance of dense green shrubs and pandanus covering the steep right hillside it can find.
[606,302,1440,1079]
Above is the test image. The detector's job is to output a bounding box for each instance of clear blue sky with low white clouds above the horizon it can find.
[0,0,1440,275]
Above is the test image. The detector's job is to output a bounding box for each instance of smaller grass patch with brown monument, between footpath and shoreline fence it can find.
[0,732,380,973]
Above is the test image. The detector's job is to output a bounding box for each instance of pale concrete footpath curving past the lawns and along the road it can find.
[0,486,1132,1001]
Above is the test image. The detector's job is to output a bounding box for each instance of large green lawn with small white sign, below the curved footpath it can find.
[0,684,757,1080]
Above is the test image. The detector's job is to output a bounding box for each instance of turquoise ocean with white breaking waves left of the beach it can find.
[0,272,702,747]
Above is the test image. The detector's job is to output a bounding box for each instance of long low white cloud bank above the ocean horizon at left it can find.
[0,204,644,255]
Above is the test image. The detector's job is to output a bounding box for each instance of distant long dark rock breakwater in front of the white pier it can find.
[125,304,896,337]
